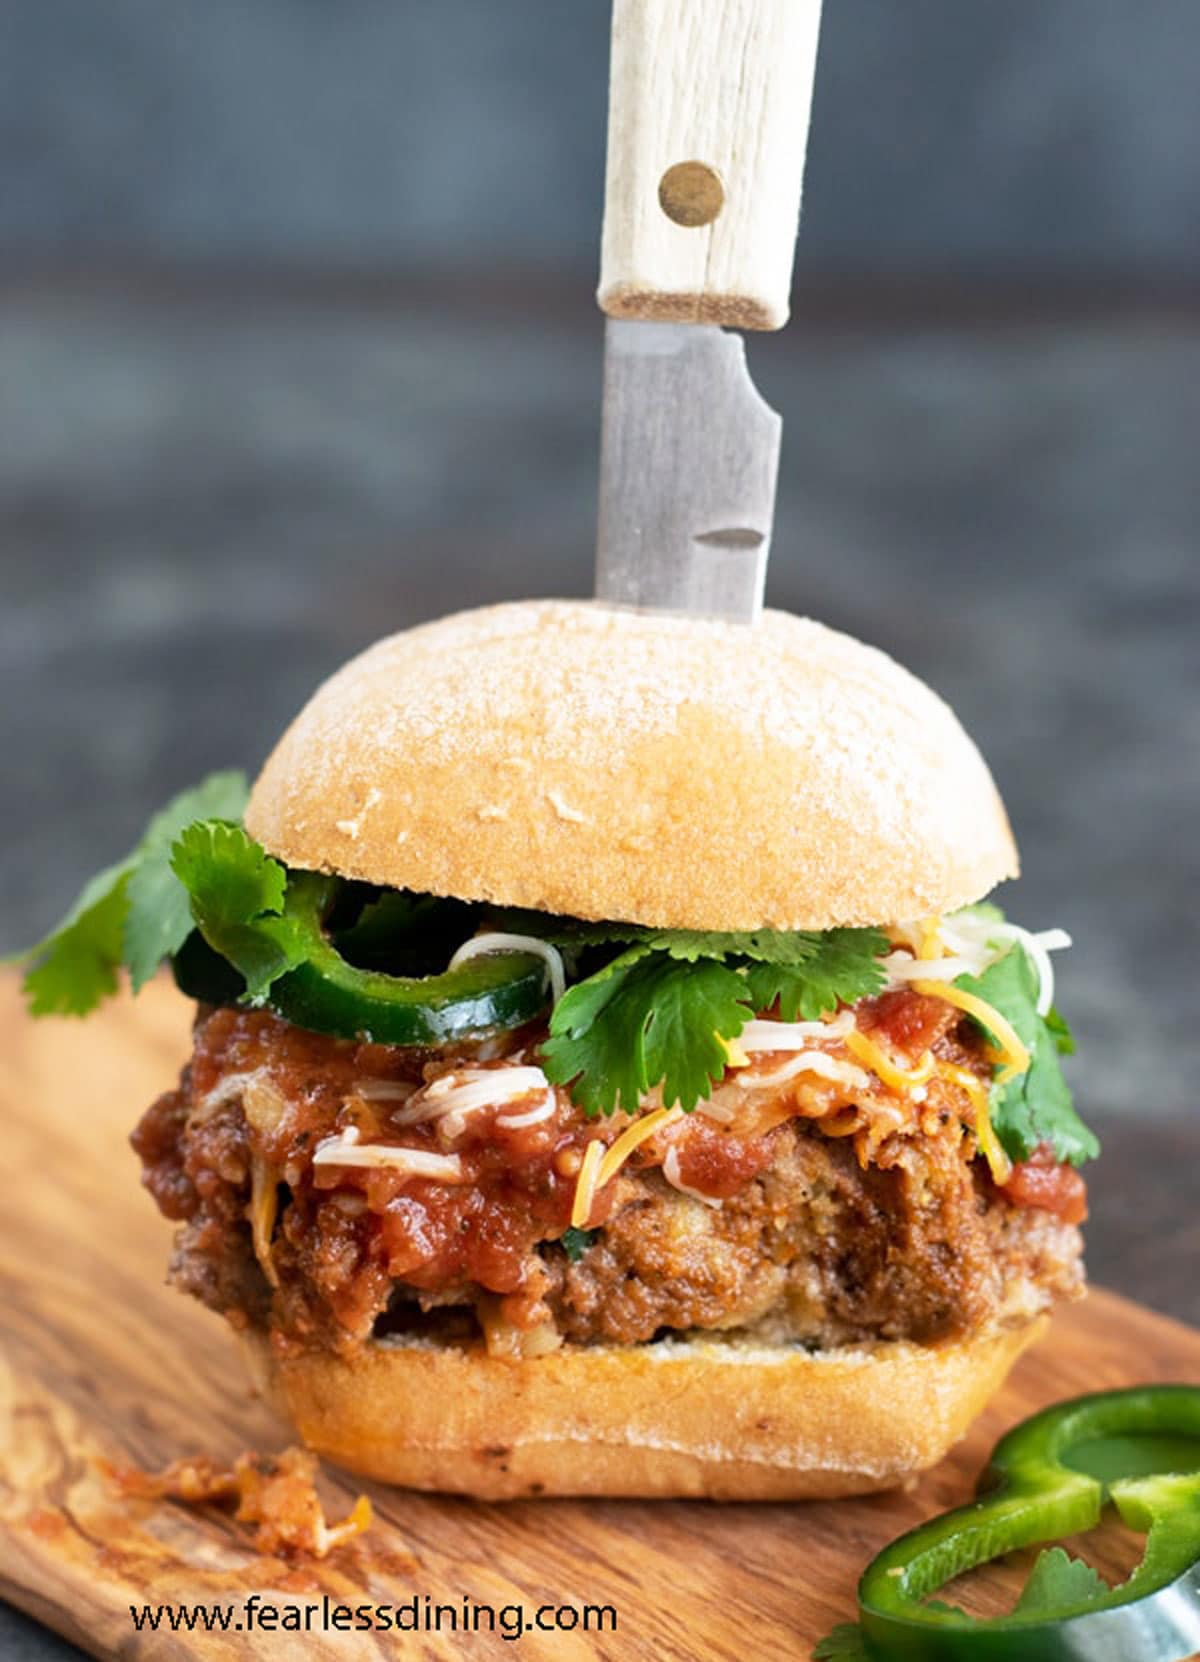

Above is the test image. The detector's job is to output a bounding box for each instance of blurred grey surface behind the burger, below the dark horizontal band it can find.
[0,278,1200,1114]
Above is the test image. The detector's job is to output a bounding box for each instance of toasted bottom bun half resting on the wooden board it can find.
[243,1318,1045,1501]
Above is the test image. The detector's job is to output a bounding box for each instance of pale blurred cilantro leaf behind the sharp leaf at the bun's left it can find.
[121,771,248,992]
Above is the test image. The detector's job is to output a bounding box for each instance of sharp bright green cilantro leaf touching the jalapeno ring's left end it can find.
[171,819,306,1004]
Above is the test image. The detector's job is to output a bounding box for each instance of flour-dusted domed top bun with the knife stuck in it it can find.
[246,600,1017,931]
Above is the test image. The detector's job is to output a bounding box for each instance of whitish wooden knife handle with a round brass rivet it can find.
[597,0,821,329]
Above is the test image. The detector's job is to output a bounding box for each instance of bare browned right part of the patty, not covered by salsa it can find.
[547,1125,1082,1346]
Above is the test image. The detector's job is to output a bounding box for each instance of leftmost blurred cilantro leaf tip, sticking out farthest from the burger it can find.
[20,858,133,1015]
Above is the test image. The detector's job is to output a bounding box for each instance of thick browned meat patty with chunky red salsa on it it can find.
[133,994,1082,1351]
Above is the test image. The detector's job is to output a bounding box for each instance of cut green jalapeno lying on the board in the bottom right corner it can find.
[859,1386,1200,1662]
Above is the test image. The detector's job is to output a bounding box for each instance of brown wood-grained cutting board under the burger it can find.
[0,979,1200,1662]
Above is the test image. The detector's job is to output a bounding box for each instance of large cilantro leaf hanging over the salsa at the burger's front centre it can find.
[542,942,751,1115]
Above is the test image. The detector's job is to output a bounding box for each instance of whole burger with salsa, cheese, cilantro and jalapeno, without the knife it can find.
[18,602,1097,1499]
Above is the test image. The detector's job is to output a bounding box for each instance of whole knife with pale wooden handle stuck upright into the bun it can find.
[595,0,821,623]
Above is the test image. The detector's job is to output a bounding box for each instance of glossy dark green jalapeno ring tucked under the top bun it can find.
[175,873,547,1047]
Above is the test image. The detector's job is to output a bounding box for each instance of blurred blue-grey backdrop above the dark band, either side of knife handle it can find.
[0,0,1200,278]
